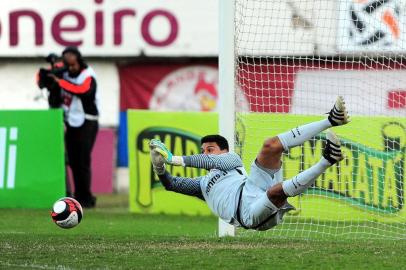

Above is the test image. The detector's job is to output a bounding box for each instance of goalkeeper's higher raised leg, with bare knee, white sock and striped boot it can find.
[257,97,349,170]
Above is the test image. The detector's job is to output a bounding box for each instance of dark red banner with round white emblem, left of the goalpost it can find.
[119,63,224,111]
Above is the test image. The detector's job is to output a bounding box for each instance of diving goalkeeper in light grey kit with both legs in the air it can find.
[150,97,349,230]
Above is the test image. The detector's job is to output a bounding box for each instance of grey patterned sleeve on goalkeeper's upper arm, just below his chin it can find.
[183,152,243,171]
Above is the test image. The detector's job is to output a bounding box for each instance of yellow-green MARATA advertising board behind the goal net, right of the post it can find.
[237,114,406,222]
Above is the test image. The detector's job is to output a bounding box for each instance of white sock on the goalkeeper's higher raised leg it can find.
[278,119,331,151]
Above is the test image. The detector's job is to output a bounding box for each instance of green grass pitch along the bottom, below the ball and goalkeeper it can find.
[0,195,406,269]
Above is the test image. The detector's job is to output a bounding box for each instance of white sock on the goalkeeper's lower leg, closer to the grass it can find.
[282,157,331,197]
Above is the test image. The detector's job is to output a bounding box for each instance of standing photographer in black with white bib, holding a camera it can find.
[39,47,99,207]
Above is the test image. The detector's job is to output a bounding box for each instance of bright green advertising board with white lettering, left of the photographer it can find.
[0,110,65,208]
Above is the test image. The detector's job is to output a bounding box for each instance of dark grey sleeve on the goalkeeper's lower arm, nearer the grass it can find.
[158,172,204,200]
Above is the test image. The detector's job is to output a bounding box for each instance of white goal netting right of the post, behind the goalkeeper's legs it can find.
[234,0,406,239]
